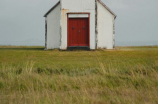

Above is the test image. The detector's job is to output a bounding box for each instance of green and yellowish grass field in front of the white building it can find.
[0,46,158,104]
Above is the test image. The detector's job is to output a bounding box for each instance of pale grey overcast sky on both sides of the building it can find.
[0,0,158,46]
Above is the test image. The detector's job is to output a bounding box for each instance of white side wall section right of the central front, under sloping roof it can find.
[97,2,114,49]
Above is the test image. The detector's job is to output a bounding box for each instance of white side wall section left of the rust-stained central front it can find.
[46,4,61,49]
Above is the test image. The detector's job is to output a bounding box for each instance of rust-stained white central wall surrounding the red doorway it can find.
[60,0,95,49]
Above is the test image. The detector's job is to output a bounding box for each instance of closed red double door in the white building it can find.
[68,18,89,47]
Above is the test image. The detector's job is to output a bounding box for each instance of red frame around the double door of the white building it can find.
[67,12,90,48]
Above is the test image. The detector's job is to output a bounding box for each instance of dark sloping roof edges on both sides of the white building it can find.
[44,0,117,18]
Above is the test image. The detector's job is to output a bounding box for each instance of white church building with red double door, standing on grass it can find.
[44,0,116,50]
